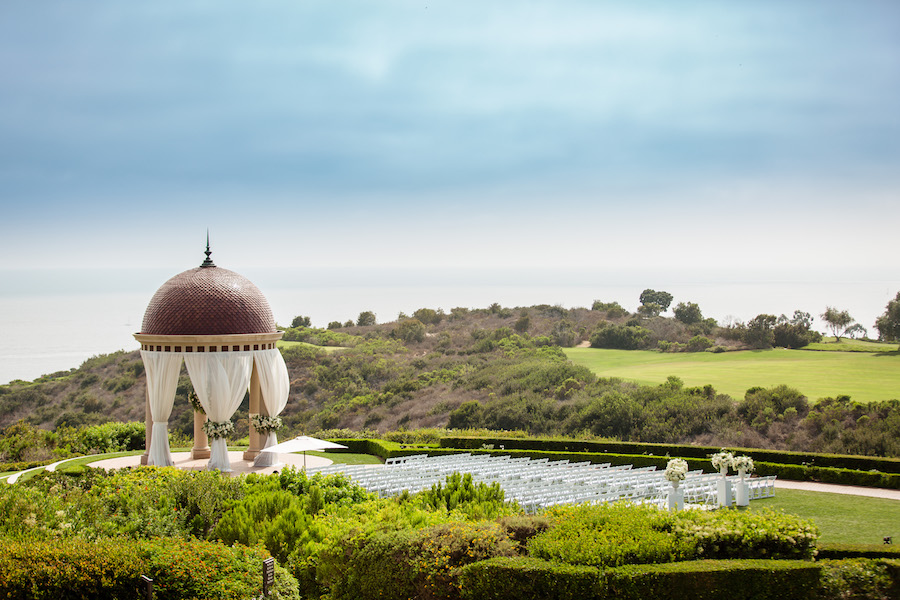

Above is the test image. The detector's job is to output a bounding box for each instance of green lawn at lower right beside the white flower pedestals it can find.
[750,489,900,544]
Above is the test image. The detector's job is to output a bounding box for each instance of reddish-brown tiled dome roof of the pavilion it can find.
[141,264,277,335]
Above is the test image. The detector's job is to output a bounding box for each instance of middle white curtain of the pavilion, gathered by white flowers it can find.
[184,352,253,472]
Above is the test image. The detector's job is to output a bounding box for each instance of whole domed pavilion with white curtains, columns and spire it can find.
[134,239,290,471]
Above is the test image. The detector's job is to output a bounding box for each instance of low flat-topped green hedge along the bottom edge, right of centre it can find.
[459,558,821,600]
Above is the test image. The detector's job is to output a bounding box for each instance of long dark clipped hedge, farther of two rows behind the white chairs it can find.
[440,437,900,474]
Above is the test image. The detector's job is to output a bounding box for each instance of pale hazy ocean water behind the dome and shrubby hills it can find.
[0,269,900,384]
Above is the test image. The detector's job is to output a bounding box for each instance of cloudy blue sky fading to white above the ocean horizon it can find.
[0,0,900,276]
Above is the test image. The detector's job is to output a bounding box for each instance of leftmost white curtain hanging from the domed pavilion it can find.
[141,350,181,467]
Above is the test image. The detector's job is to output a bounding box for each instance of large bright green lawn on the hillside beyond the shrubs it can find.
[565,348,900,402]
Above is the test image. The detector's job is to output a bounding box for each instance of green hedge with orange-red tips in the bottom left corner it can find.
[0,538,298,600]
